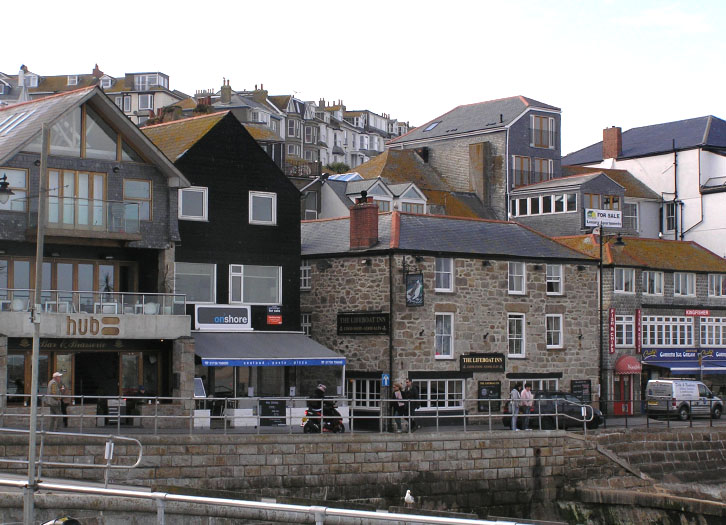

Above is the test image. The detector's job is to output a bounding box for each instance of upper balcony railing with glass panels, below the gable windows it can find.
[26,195,141,234]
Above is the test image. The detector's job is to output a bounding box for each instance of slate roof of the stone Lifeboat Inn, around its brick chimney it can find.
[302,211,593,262]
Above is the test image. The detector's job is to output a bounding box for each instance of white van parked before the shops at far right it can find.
[645,379,723,421]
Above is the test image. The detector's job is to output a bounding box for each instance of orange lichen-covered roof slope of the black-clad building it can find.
[141,111,229,162]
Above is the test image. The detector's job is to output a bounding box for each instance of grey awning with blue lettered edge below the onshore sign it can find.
[192,332,345,366]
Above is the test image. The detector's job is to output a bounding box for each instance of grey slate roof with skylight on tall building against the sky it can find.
[388,96,560,145]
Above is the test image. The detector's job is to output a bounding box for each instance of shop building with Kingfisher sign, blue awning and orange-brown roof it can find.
[556,235,726,415]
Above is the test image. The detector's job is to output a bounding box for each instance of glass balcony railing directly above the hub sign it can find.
[0,288,186,315]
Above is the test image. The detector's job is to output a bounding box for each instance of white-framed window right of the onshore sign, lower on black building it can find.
[229,264,282,305]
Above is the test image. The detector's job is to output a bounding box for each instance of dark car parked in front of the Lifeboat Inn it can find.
[502,390,603,430]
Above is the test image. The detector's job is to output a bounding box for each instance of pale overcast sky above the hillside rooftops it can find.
[0,0,726,156]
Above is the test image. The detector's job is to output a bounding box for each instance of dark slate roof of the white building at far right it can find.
[562,115,726,166]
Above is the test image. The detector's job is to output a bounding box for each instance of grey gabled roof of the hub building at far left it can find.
[0,86,189,186]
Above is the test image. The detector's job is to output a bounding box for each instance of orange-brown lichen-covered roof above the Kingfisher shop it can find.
[555,234,726,273]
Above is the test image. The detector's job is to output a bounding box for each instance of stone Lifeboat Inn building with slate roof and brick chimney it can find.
[301,195,598,424]
